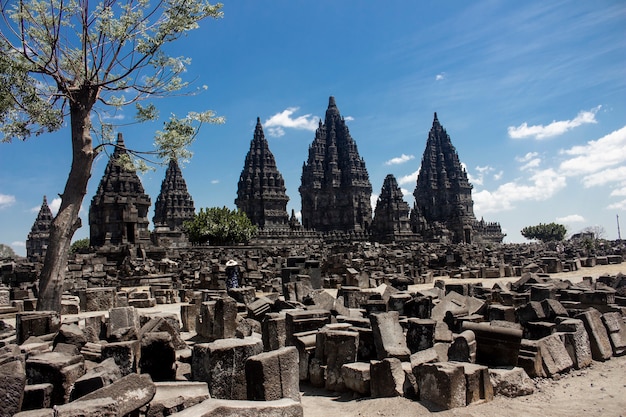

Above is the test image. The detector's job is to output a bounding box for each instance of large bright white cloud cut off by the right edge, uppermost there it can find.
[559,126,626,175]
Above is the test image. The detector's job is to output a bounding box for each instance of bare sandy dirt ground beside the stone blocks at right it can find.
[301,263,626,417]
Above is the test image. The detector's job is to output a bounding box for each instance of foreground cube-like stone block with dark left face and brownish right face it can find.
[245,346,300,401]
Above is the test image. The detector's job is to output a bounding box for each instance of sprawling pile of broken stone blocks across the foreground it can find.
[0,250,626,417]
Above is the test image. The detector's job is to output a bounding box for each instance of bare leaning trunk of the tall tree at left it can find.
[37,91,97,312]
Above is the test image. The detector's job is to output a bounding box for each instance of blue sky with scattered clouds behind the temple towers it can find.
[0,0,626,255]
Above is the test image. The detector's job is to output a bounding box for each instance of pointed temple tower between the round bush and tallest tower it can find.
[235,117,289,230]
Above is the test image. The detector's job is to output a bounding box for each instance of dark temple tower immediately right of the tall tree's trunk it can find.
[89,133,150,247]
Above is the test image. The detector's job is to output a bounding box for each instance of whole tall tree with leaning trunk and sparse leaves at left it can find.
[0,0,222,311]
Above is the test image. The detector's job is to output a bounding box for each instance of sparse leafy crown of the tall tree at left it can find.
[0,0,223,145]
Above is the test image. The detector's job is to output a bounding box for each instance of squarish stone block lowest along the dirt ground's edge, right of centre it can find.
[417,362,466,410]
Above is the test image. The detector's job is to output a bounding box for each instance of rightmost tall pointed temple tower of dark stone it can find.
[412,113,476,243]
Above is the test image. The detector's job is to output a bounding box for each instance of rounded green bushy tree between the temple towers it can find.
[184,207,257,245]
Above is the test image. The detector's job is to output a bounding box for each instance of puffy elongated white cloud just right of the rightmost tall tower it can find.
[472,168,567,214]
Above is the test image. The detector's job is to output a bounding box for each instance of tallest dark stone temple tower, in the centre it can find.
[299,96,372,232]
